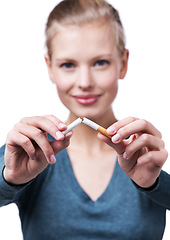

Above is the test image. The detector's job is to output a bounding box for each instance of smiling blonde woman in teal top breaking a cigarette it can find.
[0,0,170,240]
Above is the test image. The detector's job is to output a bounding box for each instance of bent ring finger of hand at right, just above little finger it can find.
[123,134,164,159]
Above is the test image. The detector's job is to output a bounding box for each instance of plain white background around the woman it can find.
[0,0,170,240]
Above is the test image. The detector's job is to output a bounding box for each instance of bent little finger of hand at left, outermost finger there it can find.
[6,131,35,160]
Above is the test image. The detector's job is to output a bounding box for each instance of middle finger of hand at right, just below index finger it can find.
[108,119,162,143]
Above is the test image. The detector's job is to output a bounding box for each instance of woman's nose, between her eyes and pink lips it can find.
[77,66,94,91]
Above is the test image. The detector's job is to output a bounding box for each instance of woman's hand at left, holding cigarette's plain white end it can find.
[3,115,72,185]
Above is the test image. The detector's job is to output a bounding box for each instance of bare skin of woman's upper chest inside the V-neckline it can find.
[66,150,116,201]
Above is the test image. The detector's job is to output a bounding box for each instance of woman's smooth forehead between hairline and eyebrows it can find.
[51,22,116,57]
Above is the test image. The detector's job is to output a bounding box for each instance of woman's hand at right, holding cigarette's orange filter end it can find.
[98,117,168,188]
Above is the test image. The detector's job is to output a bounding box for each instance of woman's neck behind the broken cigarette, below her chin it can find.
[66,110,116,152]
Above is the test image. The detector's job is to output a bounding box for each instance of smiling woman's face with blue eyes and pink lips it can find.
[46,23,128,119]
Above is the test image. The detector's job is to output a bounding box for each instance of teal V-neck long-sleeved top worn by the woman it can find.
[0,146,170,240]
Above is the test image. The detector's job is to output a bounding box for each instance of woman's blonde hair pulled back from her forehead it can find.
[45,0,126,57]
